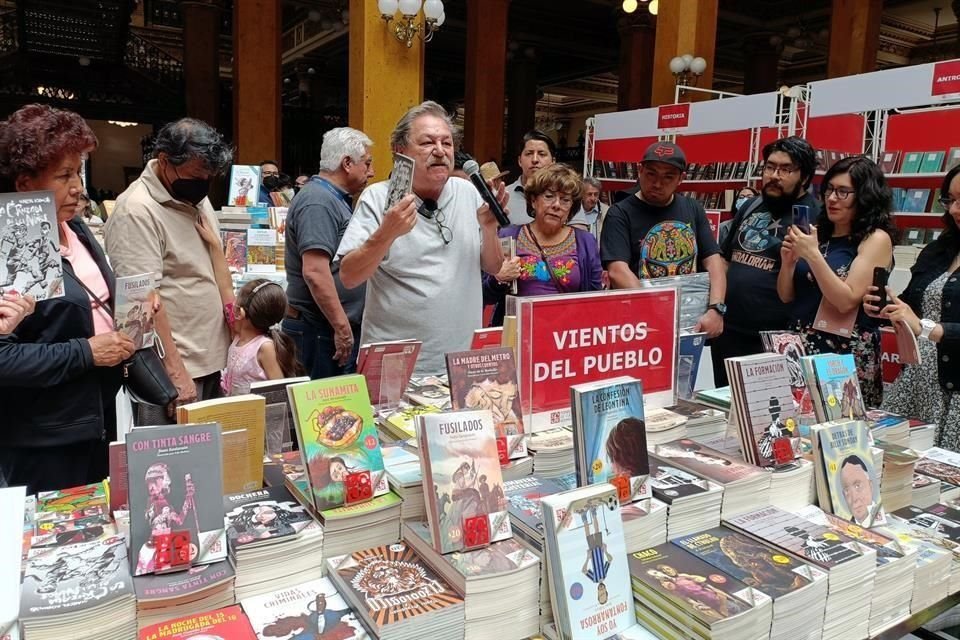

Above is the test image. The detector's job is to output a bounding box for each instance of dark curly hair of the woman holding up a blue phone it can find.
[817,156,899,245]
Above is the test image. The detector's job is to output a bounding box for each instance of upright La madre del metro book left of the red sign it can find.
[447,347,527,460]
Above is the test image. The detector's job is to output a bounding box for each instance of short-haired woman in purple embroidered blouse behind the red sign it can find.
[484,164,603,325]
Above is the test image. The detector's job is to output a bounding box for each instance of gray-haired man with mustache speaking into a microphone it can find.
[337,97,507,373]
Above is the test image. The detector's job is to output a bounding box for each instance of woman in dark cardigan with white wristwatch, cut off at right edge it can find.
[863,167,960,444]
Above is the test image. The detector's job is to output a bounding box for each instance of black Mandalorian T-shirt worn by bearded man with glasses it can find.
[722,193,820,335]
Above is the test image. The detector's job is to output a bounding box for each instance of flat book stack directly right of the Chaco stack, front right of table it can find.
[673,527,827,640]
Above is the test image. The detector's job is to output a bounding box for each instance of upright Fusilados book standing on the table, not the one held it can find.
[417,410,513,553]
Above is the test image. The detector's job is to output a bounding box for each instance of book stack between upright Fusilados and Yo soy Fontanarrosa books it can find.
[504,476,564,629]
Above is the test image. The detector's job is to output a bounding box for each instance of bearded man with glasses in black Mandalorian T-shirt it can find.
[710,136,820,386]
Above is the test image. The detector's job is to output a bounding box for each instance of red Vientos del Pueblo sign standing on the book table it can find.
[517,288,678,431]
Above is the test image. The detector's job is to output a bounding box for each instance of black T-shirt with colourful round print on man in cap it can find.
[600,195,720,278]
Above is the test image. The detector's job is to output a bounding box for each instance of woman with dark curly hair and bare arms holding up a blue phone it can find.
[777,156,897,407]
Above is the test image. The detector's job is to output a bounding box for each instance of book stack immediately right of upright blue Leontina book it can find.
[650,456,723,540]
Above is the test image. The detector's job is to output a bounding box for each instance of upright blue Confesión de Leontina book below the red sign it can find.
[570,377,650,502]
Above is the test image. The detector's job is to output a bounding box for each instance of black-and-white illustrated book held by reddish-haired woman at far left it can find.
[0,191,63,301]
